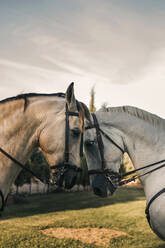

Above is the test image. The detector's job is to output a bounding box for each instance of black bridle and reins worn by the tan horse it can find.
[0,99,83,211]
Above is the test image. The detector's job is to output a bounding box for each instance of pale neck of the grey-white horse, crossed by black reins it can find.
[118,116,165,202]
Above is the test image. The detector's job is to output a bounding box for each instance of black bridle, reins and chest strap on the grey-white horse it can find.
[85,114,165,224]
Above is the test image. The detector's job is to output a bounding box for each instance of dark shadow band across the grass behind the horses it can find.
[0,188,145,220]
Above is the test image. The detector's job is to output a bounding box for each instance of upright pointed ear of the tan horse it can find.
[65,83,77,111]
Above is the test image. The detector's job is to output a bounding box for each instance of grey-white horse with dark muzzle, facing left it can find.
[84,106,165,240]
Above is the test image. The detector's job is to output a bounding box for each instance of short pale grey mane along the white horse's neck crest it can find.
[99,106,165,129]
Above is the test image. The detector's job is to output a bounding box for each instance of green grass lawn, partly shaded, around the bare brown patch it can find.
[0,188,165,248]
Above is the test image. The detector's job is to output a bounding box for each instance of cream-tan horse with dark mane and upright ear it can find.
[0,83,88,210]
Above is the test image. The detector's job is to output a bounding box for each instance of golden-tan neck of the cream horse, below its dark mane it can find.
[0,97,62,200]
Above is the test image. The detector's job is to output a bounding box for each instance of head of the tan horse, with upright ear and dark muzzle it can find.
[39,83,88,189]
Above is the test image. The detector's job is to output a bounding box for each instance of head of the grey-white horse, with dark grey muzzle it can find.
[84,112,124,197]
